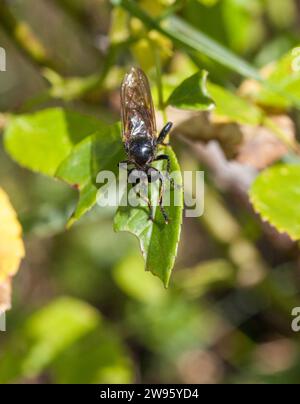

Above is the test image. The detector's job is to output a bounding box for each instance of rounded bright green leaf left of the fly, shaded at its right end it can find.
[4,108,99,176]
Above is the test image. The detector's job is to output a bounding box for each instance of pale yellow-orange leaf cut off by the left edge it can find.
[0,188,25,313]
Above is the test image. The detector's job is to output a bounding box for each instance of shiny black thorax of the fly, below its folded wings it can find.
[128,136,156,167]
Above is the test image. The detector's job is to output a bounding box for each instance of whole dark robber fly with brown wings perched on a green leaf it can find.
[120,67,172,223]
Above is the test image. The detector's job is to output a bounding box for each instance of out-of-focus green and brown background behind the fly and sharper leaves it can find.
[0,0,300,383]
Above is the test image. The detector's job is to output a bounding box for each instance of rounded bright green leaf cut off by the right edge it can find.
[250,164,300,240]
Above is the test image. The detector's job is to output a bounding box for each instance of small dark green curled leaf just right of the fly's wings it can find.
[167,71,215,111]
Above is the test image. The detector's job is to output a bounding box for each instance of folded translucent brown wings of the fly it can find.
[121,67,156,141]
